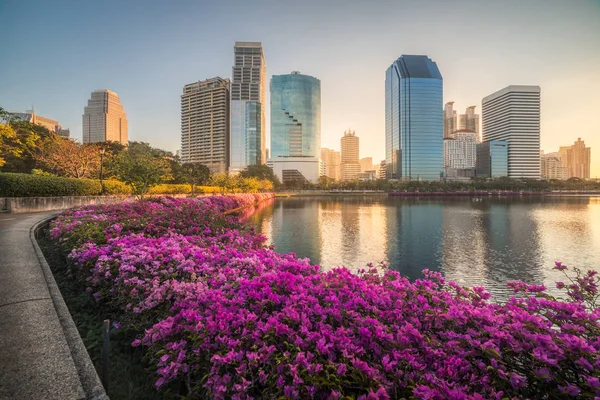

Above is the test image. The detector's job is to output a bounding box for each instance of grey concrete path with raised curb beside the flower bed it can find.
[0,212,108,400]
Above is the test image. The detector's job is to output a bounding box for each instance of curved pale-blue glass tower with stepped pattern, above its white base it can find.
[271,72,321,159]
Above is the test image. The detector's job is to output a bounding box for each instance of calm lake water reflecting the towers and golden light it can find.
[248,197,600,297]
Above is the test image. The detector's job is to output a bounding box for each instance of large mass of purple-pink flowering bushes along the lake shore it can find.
[51,198,600,399]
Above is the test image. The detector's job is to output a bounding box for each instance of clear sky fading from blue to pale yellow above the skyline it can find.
[0,0,600,177]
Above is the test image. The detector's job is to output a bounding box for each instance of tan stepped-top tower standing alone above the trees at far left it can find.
[83,90,129,145]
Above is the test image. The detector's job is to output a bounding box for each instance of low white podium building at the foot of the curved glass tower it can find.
[267,157,325,184]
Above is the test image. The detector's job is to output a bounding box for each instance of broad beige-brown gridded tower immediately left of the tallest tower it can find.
[181,77,230,172]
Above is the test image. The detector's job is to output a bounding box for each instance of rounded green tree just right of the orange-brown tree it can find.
[115,142,169,199]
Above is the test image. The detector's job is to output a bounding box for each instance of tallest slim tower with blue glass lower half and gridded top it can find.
[229,42,267,171]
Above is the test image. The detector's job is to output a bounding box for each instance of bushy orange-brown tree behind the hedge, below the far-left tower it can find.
[34,133,100,178]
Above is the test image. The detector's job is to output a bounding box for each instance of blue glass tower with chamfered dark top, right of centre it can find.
[385,55,444,180]
